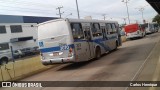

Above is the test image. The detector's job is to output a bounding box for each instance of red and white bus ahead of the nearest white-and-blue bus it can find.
[124,24,145,39]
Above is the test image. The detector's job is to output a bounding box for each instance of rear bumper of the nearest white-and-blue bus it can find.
[41,56,75,65]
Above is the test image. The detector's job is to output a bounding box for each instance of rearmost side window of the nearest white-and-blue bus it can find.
[71,23,84,39]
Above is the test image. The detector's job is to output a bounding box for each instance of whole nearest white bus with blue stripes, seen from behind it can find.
[38,19,121,65]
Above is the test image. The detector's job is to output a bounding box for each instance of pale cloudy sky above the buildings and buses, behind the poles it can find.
[0,0,157,23]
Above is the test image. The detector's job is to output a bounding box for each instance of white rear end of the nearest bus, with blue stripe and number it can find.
[38,19,74,65]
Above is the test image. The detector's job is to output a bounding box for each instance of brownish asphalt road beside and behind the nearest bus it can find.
[0,33,160,90]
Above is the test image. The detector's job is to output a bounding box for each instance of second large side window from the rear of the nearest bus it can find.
[92,23,102,37]
